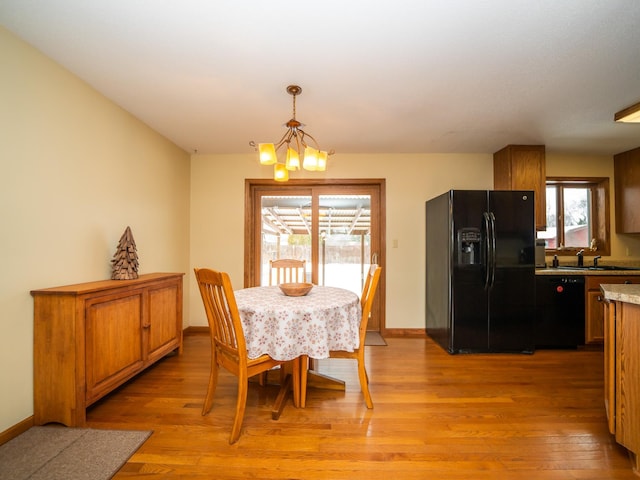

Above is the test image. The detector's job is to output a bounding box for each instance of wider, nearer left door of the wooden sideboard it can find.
[85,290,144,405]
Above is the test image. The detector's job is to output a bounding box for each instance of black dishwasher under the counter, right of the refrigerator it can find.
[535,275,585,348]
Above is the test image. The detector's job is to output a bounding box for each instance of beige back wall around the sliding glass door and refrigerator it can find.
[190,153,640,336]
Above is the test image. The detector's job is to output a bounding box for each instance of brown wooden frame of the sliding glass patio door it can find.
[244,179,386,333]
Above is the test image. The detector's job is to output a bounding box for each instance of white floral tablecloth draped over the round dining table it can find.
[235,286,362,360]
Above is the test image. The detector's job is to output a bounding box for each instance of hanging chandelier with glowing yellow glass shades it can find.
[249,85,334,182]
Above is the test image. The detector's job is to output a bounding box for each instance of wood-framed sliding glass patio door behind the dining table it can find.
[245,181,384,331]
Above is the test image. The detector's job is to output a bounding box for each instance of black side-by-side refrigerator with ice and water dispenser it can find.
[426,190,535,353]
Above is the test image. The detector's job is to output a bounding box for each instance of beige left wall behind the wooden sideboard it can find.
[0,28,190,432]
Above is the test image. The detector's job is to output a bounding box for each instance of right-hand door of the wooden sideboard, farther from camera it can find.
[148,281,182,361]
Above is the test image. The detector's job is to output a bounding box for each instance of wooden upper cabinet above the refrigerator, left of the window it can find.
[493,145,547,230]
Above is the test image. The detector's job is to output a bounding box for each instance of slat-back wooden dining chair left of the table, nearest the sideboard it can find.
[194,268,283,444]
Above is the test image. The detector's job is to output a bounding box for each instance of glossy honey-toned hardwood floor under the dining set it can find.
[87,335,638,480]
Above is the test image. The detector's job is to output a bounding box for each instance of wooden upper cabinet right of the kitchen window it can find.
[613,147,640,233]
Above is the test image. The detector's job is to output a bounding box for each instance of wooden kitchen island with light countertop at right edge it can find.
[600,284,640,475]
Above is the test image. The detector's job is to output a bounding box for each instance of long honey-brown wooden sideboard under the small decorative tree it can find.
[31,273,184,427]
